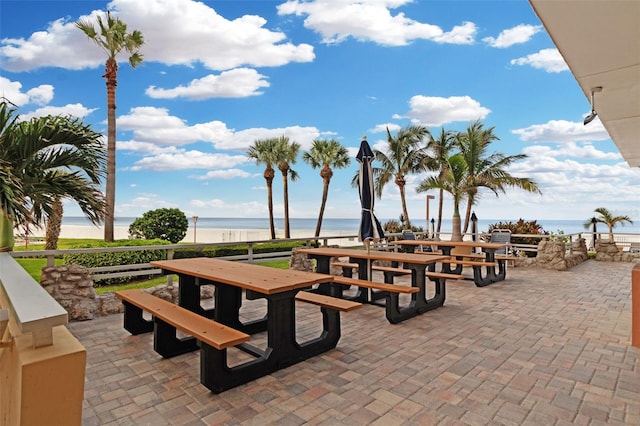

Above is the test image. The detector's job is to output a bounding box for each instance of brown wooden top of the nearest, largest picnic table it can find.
[150,257,333,294]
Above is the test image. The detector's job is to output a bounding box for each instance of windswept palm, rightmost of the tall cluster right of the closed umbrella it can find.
[455,120,541,233]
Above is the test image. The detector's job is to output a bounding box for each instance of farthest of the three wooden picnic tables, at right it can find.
[391,240,507,287]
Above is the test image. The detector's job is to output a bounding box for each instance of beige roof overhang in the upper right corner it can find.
[529,0,640,167]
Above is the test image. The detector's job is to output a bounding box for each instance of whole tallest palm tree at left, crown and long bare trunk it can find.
[76,12,144,242]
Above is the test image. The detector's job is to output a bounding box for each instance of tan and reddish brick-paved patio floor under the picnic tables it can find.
[69,261,640,426]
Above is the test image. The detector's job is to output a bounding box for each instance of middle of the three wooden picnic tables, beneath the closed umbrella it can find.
[297,247,447,324]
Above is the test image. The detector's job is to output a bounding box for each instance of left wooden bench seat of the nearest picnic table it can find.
[115,289,251,349]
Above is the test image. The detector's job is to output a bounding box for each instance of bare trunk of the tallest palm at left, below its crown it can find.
[104,58,118,242]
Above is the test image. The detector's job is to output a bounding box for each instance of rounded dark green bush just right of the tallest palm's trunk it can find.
[129,208,189,244]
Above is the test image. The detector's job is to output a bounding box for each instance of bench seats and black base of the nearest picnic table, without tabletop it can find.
[116,290,361,393]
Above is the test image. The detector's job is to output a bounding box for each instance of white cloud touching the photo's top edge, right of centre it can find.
[278,0,476,46]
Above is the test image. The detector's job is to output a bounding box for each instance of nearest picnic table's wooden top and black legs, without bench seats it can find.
[150,258,358,392]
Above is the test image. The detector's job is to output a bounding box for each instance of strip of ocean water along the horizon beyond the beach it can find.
[62,216,612,235]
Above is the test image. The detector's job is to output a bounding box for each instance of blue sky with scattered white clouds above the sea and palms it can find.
[0,0,640,230]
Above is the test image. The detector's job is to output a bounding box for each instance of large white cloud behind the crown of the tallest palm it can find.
[0,0,315,71]
